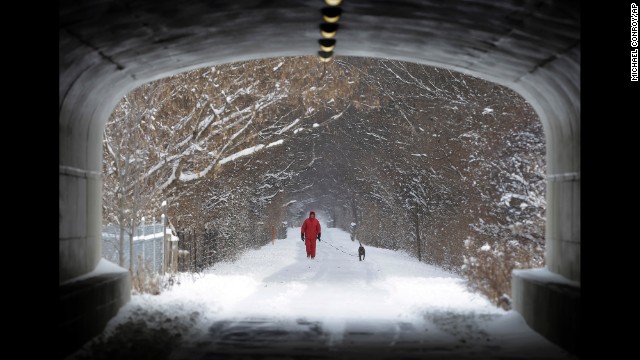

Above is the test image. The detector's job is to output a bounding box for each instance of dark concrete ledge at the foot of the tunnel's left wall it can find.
[58,271,131,358]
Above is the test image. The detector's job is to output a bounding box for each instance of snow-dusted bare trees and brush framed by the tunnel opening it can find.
[82,57,546,358]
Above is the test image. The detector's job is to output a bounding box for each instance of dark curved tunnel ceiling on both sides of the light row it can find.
[59,0,580,126]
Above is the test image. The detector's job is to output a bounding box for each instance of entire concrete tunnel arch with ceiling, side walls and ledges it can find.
[58,0,580,358]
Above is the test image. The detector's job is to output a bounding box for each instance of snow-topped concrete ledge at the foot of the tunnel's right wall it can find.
[511,269,582,356]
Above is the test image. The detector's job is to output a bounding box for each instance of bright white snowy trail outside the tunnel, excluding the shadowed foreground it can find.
[200,224,492,320]
